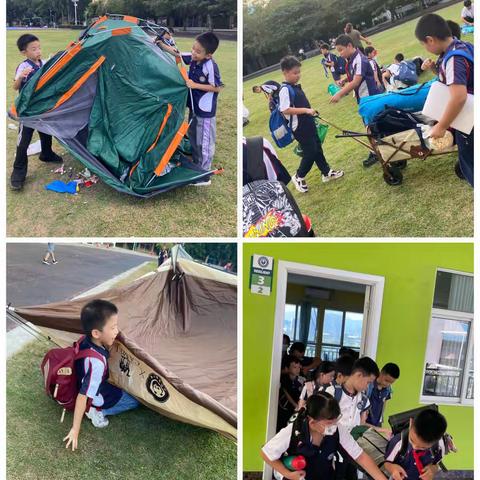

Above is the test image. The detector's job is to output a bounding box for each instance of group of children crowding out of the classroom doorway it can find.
[261,336,447,480]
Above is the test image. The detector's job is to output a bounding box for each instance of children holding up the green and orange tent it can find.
[10,25,224,190]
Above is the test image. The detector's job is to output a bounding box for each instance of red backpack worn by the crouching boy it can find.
[40,337,107,422]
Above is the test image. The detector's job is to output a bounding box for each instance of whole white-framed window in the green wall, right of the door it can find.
[421,270,474,404]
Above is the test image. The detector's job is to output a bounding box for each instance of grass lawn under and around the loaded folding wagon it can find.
[244,3,473,237]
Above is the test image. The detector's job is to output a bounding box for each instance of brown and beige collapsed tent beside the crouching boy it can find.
[7,247,237,439]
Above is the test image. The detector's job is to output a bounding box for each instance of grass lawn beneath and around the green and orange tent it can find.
[6,30,237,237]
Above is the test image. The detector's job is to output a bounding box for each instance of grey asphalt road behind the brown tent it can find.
[7,243,150,331]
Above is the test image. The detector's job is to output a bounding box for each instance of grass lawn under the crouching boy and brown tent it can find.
[7,262,237,480]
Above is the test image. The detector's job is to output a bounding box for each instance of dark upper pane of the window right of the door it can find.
[433,270,473,313]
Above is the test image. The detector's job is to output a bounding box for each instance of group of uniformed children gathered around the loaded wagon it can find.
[279,13,474,188]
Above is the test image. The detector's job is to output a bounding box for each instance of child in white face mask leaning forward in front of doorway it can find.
[260,393,385,480]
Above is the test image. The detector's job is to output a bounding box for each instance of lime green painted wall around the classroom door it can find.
[243,243,473,471]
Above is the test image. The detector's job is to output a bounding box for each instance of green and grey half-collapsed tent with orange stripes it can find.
[9,15,213,197]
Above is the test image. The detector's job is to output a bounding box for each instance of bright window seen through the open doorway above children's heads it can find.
[320,310,363,361]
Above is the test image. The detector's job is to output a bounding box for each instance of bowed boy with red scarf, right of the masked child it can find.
[384,410,447,480]
